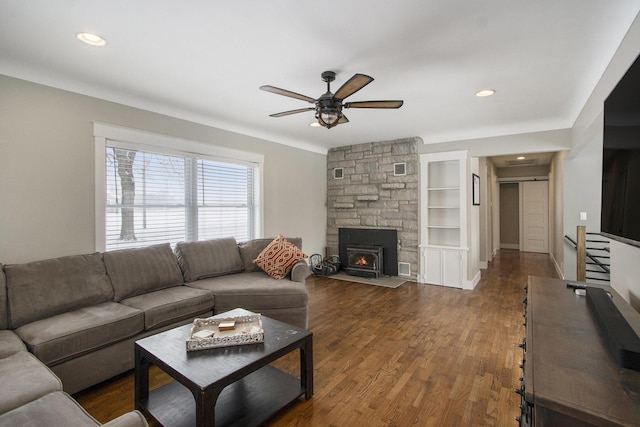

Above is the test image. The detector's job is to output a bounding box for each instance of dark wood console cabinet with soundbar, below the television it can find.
[516,276,640,426]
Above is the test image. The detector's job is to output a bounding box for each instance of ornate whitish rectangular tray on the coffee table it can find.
[187,312,264,351]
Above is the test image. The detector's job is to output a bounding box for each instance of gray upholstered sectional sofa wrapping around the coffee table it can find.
[0,238,310,425]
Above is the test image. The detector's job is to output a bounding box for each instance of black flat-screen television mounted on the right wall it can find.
[600,53,640,247]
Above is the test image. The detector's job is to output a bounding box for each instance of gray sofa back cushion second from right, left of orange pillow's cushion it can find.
[176,237,244,282]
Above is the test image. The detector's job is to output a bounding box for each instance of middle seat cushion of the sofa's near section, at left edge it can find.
[0,351,62,416]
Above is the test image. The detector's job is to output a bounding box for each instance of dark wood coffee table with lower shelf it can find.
[135,310,313,427]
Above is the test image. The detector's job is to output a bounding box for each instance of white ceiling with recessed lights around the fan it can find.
[0,0,640,153]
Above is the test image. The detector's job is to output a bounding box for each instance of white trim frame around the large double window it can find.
[93,122,264,252]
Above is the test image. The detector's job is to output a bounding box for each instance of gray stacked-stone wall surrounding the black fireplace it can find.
[327,138,421,280]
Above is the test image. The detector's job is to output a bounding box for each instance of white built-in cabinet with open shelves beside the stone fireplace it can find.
[418,151,471,288]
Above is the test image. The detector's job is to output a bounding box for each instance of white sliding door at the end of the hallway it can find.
[521,181,549,253]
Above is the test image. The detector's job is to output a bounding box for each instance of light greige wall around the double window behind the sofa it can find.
[0,76,326,263]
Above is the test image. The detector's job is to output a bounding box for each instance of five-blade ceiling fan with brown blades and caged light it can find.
[260,71,403,129]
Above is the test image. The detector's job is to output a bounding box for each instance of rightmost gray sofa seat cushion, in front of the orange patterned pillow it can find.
[188,271,309,313]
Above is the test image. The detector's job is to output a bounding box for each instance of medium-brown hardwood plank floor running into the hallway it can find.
[75,250,557,427]
